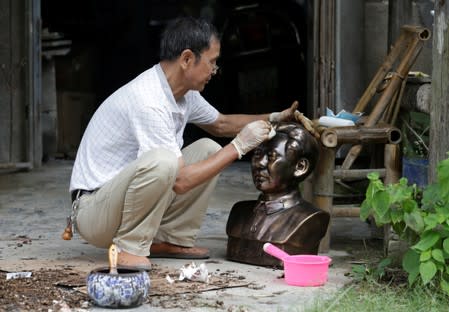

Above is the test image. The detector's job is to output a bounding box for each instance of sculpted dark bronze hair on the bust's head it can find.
[275,122,319,178]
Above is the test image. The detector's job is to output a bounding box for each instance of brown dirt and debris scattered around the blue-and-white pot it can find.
[0,265,257,311]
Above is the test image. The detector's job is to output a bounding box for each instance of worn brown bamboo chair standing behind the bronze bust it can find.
[308,25,430,252]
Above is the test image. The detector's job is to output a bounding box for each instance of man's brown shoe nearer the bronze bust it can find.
[150,243,209,259]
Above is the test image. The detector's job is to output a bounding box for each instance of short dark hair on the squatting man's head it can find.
[160,17,220,61]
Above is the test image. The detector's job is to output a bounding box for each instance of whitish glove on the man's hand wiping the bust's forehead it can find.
[231,120,276,159]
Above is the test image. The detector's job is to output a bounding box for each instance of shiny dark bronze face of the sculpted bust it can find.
[251,134,297,195]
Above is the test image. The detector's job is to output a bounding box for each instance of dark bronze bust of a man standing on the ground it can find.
[226,122,330,266]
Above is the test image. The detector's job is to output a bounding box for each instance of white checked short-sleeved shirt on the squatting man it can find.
[70,64,218,191]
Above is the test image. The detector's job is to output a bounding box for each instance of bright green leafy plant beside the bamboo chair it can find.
[360,158,449,294]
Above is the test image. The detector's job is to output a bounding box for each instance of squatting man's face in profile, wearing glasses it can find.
[188,39,220,92]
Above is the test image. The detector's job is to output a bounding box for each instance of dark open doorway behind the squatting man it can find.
[41,0,307,155]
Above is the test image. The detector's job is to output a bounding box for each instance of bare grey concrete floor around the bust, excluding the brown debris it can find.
[0,160,378,311]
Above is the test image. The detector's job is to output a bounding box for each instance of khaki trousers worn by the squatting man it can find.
[75,139,221,256]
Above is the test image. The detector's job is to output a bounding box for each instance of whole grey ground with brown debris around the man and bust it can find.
[0,162,382,312]
